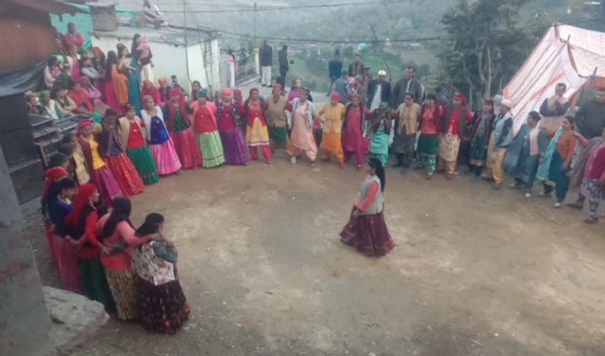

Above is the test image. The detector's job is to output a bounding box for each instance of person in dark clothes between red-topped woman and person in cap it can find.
[469,99,496,177]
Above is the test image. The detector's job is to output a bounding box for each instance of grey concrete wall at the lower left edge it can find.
[0,148,54,356]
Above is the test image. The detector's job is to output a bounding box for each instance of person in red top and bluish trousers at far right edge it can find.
[567,131,605,224]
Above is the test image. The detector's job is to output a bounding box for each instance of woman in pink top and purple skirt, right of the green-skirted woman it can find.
[216,88,250,166]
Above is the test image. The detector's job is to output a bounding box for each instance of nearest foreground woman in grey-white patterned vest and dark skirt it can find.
[134,213,189,334]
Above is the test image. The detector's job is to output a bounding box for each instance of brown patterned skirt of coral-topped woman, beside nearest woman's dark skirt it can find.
[105,269,139,320]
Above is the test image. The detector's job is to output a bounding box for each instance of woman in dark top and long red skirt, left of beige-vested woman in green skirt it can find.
[97,109,143,196]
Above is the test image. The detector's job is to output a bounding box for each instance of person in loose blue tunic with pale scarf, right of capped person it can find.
[504,111,548,199]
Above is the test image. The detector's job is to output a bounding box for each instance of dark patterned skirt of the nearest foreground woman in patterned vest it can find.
[137,276,189,334]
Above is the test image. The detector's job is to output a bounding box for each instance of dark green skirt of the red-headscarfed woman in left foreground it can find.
[80,258,116,312]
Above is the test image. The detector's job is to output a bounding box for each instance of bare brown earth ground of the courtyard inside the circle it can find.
[26,154,605,356]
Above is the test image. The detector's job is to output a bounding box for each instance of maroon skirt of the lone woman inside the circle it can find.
[340,209,395,257]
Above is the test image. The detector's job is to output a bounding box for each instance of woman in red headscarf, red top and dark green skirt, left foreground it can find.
[65,183,115,312]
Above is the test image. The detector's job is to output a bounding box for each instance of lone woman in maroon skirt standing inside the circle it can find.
[340,157,395,256]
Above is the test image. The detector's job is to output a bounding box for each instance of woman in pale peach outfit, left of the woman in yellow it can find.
[286,89,318,166]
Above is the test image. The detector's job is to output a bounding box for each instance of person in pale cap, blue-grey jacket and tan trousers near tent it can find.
[483,99,513,189]
